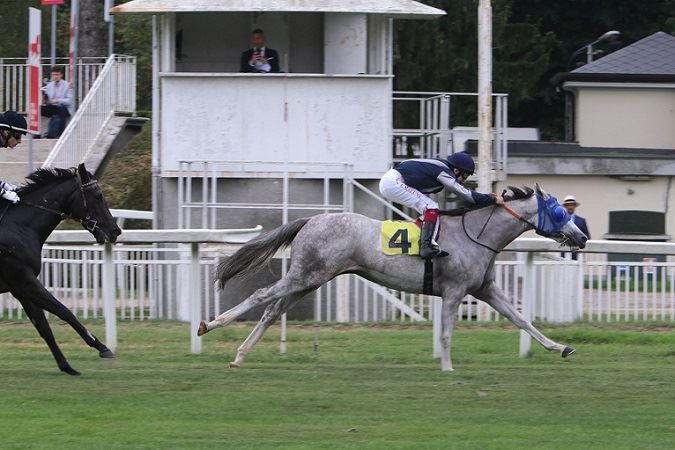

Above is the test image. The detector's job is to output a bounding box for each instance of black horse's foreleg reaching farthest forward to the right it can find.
[5,271,114,358]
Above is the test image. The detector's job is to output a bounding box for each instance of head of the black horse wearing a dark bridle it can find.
[70,164,122,244]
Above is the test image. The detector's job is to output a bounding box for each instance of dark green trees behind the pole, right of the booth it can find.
[395,0,675,139]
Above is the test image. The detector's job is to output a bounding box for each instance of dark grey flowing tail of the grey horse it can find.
[216,217,310,289]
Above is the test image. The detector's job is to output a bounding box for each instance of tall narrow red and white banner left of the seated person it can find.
[28,8,42,134]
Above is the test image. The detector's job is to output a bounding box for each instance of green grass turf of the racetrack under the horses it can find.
[0,321,675,449]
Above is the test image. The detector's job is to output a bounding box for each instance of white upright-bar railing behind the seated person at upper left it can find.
[0,56,106,114]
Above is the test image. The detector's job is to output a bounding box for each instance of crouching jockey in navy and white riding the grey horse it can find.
[380,152,504,259]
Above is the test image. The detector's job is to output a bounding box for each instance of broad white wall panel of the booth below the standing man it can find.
[160,74,392,178]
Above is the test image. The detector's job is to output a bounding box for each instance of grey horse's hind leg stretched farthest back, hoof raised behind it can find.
[197,273,312,336]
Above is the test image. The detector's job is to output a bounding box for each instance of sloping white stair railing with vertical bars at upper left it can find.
[43,55,136,167]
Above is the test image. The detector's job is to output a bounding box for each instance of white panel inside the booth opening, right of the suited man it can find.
[324,13,368,74]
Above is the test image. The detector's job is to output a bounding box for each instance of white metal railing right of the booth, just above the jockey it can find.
[393,91,508,180]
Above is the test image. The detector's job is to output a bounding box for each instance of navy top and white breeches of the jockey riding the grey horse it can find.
[380,159,495,214]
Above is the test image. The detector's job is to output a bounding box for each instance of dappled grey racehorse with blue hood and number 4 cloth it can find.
[198,185,587,371]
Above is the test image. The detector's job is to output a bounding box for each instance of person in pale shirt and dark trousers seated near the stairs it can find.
[41,66,75,139]
